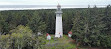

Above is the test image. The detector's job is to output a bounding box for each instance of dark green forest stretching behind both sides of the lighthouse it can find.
[0,9,73,34]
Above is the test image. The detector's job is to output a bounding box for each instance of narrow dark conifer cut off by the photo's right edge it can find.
[103,5,111,34]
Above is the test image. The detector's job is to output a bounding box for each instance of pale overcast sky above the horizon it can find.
[0,0,111,5]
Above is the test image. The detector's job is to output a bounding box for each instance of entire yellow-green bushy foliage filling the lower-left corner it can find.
[0,25,45,49]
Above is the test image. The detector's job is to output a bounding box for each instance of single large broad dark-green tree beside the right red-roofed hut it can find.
[72,6,105,46]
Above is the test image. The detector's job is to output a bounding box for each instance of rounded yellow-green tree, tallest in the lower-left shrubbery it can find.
[10,25,32,49]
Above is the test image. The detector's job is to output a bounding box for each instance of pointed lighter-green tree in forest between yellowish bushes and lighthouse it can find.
[28,11,46,33]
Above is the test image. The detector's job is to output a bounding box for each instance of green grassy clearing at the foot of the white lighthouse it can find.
[38,35,100,49]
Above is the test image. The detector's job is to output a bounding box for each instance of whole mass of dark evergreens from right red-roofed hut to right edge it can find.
[72,6,111,47]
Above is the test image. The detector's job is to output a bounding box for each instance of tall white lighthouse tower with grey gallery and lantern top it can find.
[55,4,63,38]
